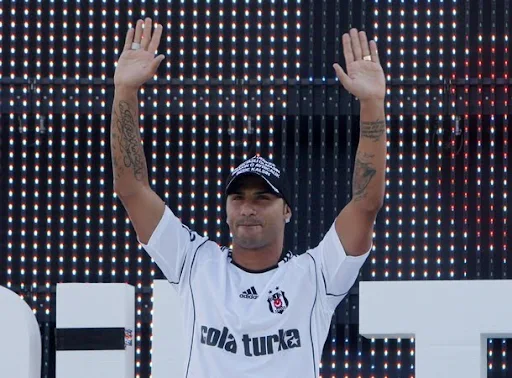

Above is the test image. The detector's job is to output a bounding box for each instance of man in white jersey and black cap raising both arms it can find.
[111,18,386,378]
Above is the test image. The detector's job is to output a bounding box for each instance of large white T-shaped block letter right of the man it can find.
[359,280,512,378]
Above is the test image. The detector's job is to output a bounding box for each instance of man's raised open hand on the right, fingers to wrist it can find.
[333,29,386,101]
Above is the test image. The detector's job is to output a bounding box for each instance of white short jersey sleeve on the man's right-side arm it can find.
[308,223,371,312]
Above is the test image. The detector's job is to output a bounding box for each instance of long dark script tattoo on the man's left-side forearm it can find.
[112,101,148,181]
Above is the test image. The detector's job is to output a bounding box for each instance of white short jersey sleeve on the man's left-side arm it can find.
[139,205,207,285]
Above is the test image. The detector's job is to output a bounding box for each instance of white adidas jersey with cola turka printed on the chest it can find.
[143,206,369,378]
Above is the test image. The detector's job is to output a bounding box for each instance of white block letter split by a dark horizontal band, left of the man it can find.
[56,283,135,378]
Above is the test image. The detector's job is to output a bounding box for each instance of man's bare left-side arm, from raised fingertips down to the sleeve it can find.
[110,19,165,243]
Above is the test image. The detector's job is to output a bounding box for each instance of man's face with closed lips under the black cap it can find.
[226,176,291,249]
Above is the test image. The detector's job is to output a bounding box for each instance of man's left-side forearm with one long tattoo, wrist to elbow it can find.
[110,88,149,197]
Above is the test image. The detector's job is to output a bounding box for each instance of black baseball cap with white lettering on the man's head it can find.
[225,156,292,208]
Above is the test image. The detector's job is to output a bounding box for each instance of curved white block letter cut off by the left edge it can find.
[0,286,41,378]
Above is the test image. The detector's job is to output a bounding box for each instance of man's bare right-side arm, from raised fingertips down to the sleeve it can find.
[335,29,386,256]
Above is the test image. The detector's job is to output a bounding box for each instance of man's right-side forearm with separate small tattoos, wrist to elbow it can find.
[352,101,386,210]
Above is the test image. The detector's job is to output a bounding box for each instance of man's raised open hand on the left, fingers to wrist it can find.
[114,18,164,90]
